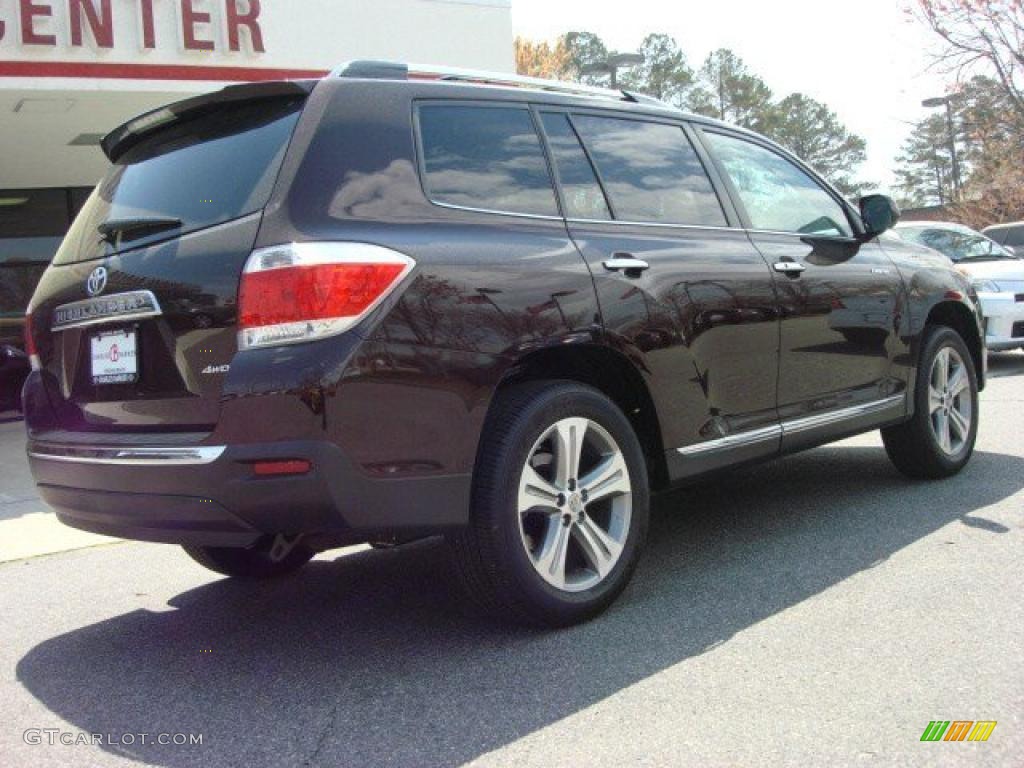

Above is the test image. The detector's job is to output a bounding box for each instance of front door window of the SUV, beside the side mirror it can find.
[705,132,853,237]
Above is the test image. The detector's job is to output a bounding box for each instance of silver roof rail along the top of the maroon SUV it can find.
[330,60,675,110]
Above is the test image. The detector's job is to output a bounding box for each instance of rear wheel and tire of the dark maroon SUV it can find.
[450,381,649,627]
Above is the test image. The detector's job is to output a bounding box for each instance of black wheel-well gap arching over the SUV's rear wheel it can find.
[488,344,669,489]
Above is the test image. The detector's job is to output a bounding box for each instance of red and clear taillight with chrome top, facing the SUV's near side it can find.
[239,243,416,349]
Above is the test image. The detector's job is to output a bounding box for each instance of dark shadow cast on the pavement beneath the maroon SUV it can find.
[17,446,1024,767]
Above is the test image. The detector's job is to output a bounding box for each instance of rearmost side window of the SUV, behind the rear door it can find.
[419,104,558,216]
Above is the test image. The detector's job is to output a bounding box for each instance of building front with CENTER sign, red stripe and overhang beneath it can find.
[0,0,514,189]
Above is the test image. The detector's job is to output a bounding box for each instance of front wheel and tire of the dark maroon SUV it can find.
[882,326,978,479]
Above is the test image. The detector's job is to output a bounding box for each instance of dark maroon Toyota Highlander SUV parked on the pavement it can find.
[25,62,985,625]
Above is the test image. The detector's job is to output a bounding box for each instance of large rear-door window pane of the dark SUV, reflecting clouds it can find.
[572,115,727,226]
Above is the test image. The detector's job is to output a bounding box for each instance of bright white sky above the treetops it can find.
[512,0,950,190]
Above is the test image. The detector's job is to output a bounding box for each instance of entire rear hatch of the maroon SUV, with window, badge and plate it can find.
[33,86,305,432]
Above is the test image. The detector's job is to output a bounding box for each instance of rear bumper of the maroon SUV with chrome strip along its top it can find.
[29,435,470,547]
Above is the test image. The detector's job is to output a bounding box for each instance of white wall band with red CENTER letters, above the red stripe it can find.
[0,0,513,77]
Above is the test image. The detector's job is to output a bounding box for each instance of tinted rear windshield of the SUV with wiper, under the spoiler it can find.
[54,97,302,264]
